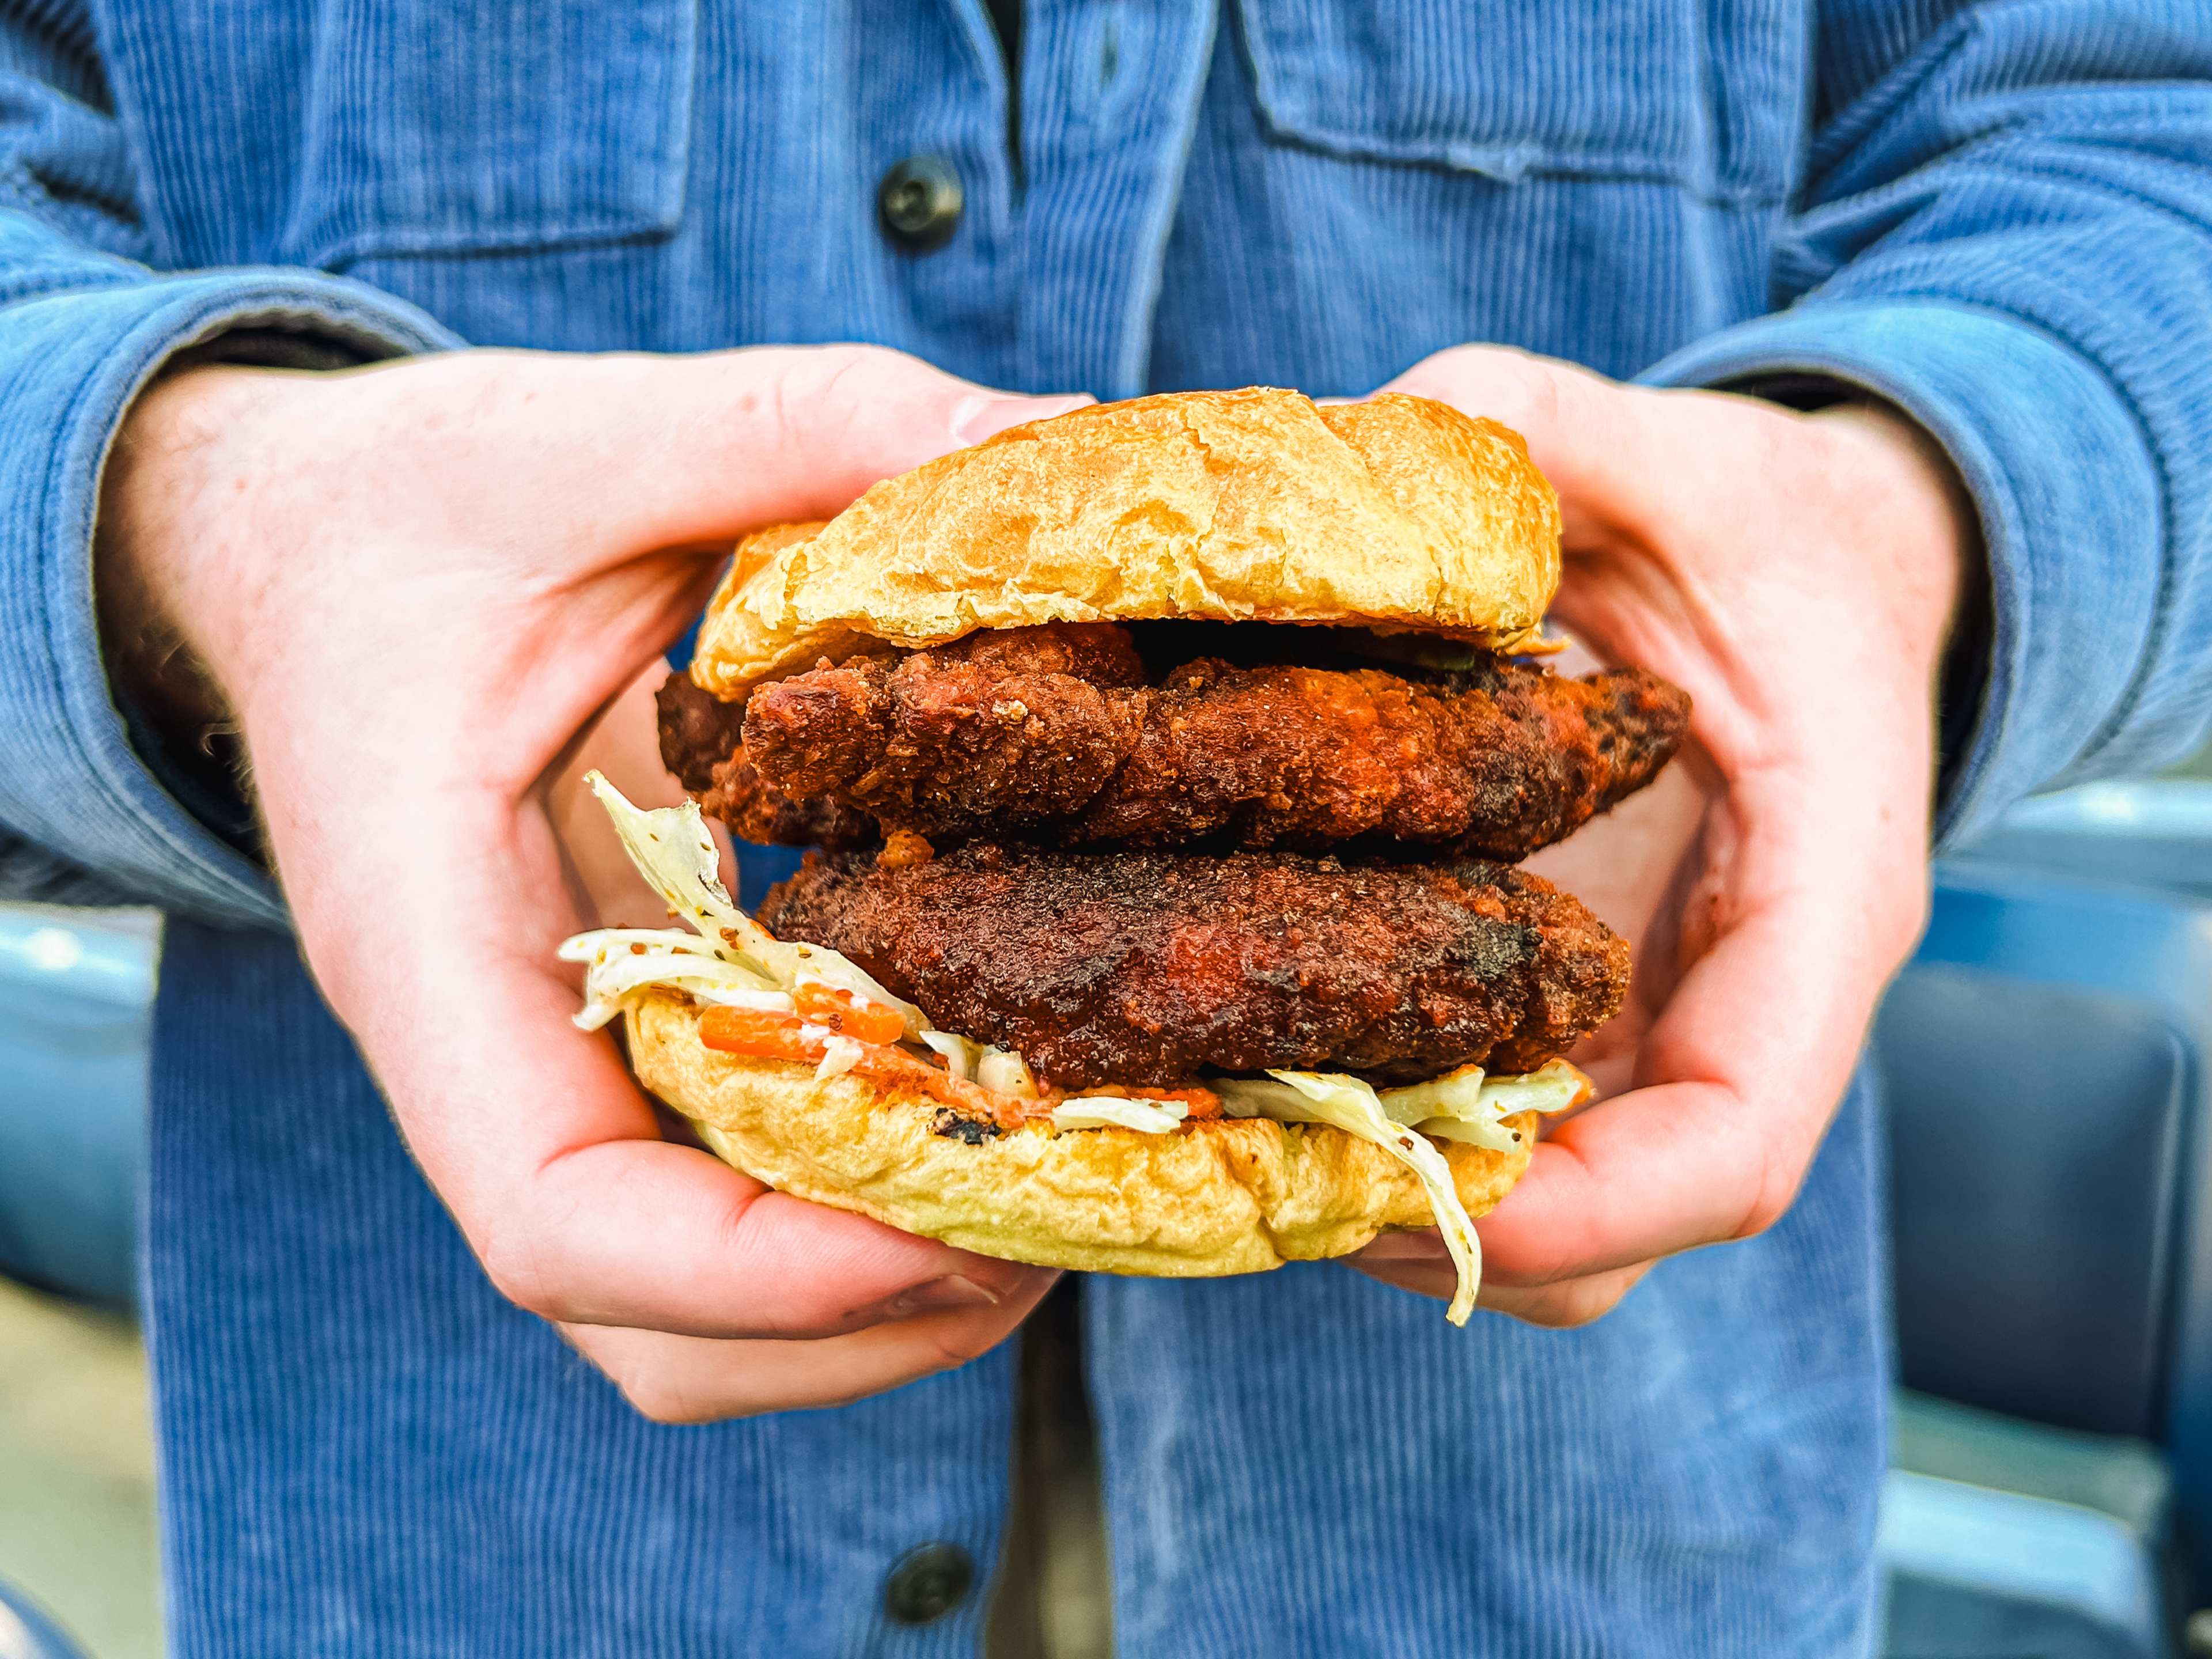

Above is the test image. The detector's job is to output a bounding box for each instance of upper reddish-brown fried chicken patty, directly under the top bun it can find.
[741,624,1690,858]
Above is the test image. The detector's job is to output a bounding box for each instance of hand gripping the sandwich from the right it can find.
[1358,347,1978,1325]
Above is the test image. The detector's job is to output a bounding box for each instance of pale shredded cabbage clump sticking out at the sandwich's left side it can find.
[562,772,929,1037]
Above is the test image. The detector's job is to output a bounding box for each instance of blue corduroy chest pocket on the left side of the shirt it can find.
[281,0,697,270]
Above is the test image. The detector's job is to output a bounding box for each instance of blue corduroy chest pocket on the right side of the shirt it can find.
[1241,0,1809,199]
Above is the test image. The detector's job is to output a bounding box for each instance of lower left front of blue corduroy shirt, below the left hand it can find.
[146,922,1009,1659]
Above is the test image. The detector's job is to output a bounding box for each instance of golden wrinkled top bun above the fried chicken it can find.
[692,387,1559,699]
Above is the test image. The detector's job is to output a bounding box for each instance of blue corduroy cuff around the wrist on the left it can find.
[0,270,460,925]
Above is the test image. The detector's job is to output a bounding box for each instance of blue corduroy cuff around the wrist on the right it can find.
[1639,298,2165,845]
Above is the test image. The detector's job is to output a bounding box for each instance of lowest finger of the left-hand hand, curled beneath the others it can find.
[562,1272,1058,1422]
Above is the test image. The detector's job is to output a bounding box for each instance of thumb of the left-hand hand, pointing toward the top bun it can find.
[457,345,1090,551]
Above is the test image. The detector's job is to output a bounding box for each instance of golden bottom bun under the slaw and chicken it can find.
[628,993,1535,1279]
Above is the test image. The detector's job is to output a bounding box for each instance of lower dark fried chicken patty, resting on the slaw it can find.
[761,843,1628,1088]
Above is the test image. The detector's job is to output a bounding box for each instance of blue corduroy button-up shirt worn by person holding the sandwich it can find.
[0,0,2212,1659]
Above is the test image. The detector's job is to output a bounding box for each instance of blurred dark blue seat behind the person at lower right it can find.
[1876,781,2212,1659]
